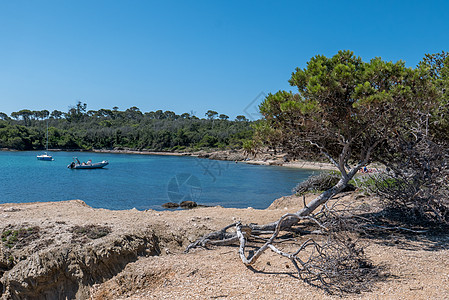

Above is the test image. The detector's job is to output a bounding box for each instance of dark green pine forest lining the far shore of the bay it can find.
[0,105,253,151]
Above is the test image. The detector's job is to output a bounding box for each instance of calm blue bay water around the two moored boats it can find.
[0,151,313,210]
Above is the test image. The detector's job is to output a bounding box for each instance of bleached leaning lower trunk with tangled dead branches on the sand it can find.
[185,159,377,292]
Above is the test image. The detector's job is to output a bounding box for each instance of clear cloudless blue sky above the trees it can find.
[0,0,449,118]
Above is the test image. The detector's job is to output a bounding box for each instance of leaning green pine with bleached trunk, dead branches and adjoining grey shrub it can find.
[187,51,449,292]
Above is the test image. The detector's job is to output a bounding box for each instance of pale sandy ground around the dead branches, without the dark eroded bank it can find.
[0,196,449,299]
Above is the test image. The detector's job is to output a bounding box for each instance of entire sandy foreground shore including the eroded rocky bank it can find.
[0,193,449,299]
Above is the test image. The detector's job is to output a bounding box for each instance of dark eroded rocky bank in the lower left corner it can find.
[0,232,160,299]
